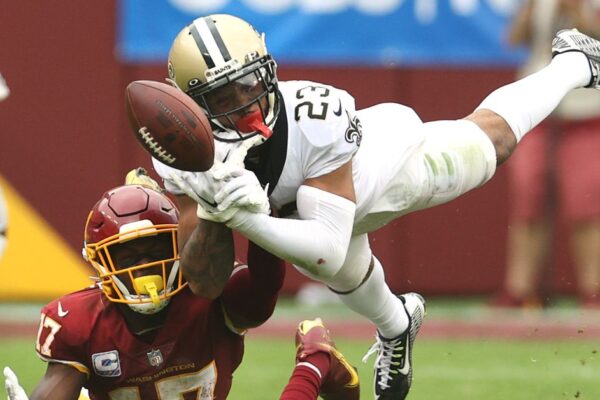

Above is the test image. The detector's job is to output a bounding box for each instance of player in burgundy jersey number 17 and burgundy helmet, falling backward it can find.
[5,185,358,400]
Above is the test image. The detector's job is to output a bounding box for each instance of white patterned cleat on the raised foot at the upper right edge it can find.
[552,29,600,89]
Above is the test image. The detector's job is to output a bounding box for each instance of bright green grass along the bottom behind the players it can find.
[0,333,600,400]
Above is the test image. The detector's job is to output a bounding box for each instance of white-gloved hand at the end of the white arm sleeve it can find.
[215,168,271,215]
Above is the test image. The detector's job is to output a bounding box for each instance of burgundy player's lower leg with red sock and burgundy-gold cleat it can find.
[280,318,360,400]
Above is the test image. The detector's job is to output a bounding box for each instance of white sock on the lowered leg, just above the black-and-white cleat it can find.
[338,256,408,339]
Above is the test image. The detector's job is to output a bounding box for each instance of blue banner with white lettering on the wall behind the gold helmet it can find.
[118,0,524,66]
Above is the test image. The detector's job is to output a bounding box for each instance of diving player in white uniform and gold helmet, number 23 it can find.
[153,15,600,399]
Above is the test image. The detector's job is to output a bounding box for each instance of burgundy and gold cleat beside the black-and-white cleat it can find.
[296,318,360,400]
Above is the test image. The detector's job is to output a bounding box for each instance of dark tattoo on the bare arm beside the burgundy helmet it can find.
[180,220,235,298]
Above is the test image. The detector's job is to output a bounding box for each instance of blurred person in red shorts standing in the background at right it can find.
[492,0,600,307]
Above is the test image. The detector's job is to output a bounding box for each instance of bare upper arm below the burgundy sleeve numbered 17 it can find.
[29,362,86,400]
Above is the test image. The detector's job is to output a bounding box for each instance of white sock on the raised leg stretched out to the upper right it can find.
[477,52,591,142]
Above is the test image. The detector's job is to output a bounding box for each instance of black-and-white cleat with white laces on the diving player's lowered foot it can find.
[363,293,425,400]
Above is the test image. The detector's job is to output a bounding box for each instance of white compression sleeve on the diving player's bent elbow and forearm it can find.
[227,185,356,278]
